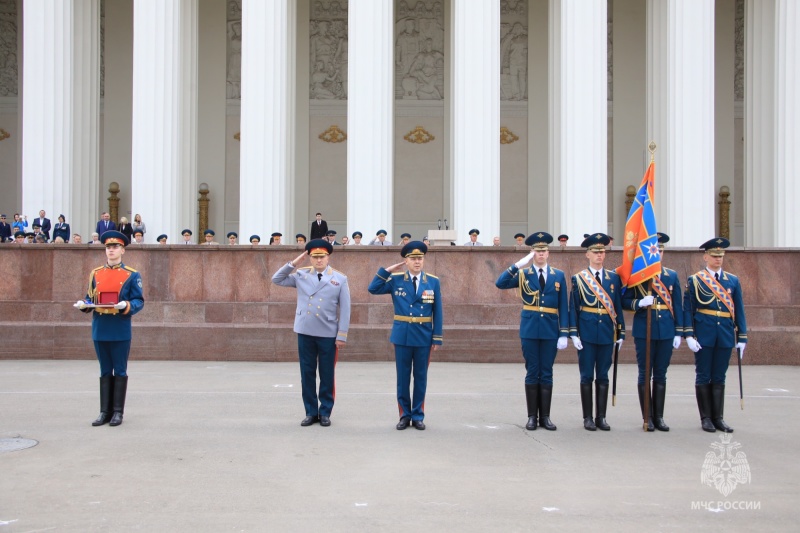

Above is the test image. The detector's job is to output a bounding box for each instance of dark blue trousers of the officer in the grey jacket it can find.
[297,333,339,416]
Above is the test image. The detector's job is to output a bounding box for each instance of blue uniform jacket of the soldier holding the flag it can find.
[622,268,684,340]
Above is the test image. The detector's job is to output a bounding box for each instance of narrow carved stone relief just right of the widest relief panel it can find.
[500,0,528,101]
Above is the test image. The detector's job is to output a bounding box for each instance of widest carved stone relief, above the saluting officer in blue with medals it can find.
[394,0,444,100]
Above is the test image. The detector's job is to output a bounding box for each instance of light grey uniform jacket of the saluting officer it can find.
[272,263,350,342]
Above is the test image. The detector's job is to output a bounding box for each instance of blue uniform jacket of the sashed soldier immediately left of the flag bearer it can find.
[569,268,625,344]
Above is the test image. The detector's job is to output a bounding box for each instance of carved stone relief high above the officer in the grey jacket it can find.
[309,0,347,100]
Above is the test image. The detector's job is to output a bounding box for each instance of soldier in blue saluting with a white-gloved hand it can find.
[495,231,569,431]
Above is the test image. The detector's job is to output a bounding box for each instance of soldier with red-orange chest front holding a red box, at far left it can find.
[75,230,144,426]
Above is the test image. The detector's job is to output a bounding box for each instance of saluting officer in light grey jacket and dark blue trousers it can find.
[272,239,350,427]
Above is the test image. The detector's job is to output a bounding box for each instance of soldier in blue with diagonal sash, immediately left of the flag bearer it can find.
[569,233,625,431]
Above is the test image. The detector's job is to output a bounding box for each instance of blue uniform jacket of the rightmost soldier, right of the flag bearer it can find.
[683,270,747,348]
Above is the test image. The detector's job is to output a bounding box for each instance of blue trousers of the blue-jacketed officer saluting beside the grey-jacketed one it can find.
[394,344,431,420]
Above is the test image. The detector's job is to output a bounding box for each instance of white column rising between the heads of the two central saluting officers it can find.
[347,0,392,241]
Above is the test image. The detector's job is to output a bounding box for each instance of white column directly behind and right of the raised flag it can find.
[643,0,717,247]
